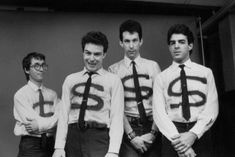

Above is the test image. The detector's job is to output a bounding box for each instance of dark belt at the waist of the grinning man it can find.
[69,121,108,130]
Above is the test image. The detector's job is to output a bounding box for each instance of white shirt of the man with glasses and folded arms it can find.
[13,81,59,137]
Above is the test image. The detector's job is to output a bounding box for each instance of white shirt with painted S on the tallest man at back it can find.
[109,56,160,117]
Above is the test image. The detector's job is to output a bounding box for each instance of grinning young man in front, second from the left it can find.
[53,32,124,157]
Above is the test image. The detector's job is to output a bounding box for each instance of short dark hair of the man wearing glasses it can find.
[22,52,46,81]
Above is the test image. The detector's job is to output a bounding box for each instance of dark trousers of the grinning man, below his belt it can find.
[65,124,109,157]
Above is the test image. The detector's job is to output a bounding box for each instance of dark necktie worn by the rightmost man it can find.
[179,64,190,120]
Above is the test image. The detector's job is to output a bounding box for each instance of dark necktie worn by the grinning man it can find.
[78,72,94,129]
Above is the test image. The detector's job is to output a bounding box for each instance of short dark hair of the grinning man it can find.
[82,31,109,53]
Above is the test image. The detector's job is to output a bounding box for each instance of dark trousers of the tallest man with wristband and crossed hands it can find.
[120,118,161,157]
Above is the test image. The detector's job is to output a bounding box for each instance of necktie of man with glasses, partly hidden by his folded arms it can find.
[38,89,47,149]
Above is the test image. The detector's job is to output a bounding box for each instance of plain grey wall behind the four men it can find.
[0,11,200,157]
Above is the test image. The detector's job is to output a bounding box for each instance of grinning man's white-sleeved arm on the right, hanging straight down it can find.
[107,77,124,155]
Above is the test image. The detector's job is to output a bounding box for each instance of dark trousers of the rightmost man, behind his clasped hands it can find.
[162,122,213,157]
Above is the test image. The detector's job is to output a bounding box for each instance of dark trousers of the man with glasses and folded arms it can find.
[17,136,54,157]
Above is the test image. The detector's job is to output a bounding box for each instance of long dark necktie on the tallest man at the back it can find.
[132,61,147,125]
